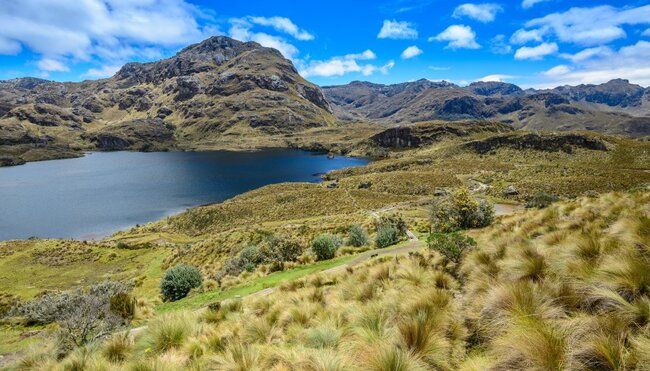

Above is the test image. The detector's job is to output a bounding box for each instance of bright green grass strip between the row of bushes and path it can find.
[156,255,359,314]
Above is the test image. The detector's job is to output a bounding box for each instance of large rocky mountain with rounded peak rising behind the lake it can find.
[0,36,335,163]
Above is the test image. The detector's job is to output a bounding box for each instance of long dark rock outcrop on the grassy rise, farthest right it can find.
[464,133,607,154]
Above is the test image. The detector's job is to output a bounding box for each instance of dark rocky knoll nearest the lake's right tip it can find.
[370,121,514,148]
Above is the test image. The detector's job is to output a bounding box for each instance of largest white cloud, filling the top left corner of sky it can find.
[0,0,207,71]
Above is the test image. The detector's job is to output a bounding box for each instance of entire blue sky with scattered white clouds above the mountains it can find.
[0,0,650,88]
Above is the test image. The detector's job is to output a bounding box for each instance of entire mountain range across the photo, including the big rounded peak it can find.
[0,36,650,165]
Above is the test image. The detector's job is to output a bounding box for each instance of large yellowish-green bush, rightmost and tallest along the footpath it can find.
[431,189,494,233]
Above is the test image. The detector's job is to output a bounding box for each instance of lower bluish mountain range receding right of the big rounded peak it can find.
[323,79,650,136]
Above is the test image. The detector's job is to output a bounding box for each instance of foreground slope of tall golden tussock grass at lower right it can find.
[16,190,650,370]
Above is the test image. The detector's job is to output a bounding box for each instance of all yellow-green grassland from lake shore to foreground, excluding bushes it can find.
[0,123,650,370]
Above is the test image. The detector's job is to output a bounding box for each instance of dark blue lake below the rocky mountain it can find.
[0,149,368,240]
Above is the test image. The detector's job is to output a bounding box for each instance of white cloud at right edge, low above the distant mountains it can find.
[535,40,650,88]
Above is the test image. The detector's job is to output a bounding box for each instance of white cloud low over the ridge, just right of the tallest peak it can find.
[299,50,395,77]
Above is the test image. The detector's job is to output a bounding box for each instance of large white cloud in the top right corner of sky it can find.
[513,5,650,46]
